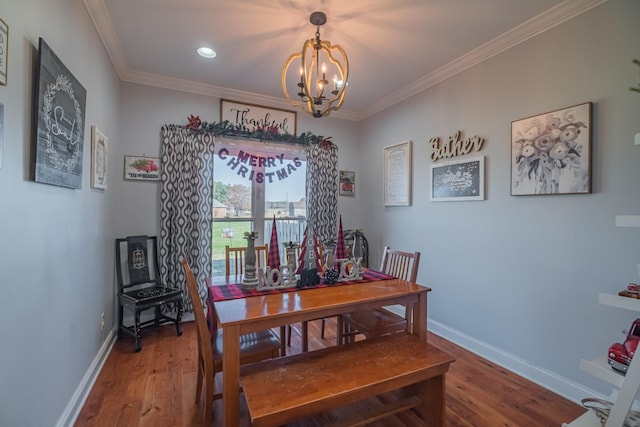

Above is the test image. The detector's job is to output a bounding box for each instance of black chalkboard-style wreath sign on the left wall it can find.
[31,38,87,188]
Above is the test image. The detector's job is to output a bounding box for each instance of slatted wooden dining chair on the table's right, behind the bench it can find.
[336,246,420,344]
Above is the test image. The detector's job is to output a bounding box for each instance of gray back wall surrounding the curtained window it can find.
[113,83,358,235]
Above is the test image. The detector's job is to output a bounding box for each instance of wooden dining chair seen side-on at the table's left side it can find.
[182,259,282,427]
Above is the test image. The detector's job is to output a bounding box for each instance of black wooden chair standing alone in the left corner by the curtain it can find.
[116,236,183,352]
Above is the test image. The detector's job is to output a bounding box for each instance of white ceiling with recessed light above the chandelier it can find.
[84,0,606,120]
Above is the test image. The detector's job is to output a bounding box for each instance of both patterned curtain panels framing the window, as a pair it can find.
[159,125,338,312]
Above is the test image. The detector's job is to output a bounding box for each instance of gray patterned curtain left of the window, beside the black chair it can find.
[159,125,214,312]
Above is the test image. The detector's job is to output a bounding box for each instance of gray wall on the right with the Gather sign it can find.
[358,0,640,399]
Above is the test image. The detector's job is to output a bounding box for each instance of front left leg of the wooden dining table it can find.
[222,325,240,427]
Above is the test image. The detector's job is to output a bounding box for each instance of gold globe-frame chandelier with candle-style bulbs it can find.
[282,12,349,117]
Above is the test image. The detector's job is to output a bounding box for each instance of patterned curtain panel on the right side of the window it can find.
[307,143,338,246]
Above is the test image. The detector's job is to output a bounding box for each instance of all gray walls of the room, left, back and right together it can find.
[0,0,640,426]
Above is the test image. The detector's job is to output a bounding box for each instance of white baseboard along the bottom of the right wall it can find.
[427,319,607,404]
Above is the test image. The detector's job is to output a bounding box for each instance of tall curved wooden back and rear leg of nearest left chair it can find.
[182,259,215,426]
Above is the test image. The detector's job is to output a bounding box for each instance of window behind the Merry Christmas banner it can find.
[212,139,307,275]
